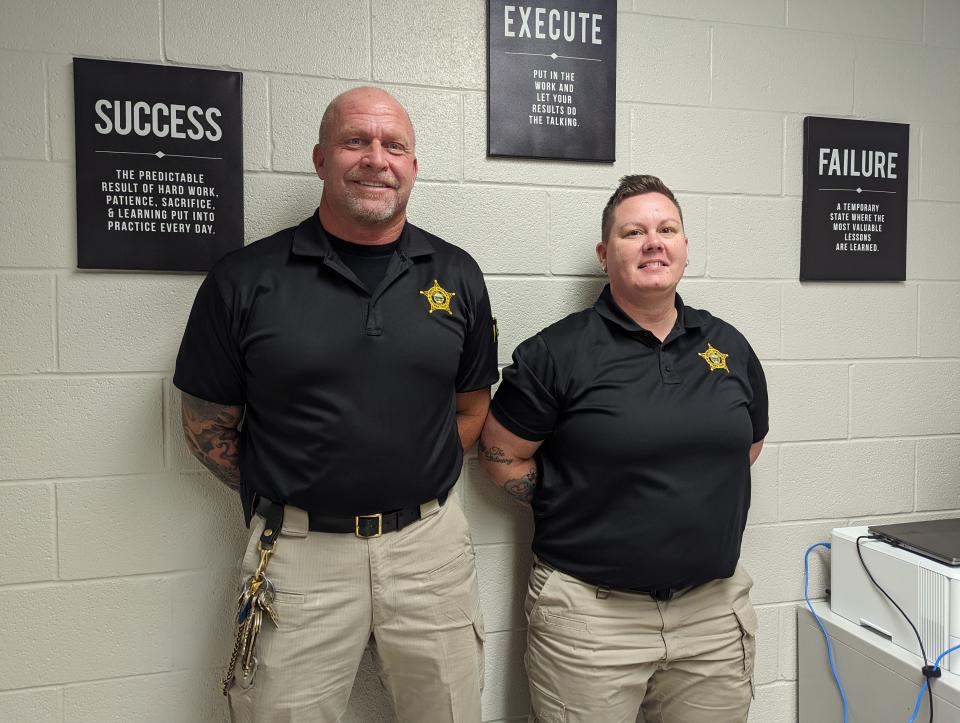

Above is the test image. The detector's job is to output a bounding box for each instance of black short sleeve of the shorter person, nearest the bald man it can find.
[490,334,560,442]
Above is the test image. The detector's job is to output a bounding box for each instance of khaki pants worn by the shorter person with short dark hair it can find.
[525,561,757,723]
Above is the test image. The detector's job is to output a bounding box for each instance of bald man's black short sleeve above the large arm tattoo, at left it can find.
[173,273,246,405]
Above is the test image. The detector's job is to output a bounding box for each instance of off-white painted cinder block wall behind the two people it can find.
[0,0,960,723]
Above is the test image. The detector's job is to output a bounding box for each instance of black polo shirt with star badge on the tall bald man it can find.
[174,214,498,516]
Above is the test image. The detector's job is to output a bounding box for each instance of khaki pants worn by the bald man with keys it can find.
[229,501,484,723]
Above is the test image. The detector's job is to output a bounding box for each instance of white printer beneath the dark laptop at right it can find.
[830,527,960,673]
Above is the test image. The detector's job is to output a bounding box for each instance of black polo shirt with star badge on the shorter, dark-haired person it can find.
[491,287,767,590]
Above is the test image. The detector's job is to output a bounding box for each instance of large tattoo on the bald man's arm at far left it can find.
[181,394,243,490]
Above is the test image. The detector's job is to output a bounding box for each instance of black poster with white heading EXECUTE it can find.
[487,0,617,161]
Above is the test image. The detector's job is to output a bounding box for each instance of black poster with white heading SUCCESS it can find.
[73,58,243,271]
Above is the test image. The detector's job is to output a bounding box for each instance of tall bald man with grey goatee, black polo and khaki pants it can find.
[174,88,497,723]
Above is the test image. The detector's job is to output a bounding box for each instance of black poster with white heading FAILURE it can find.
[800,116,910,281]
